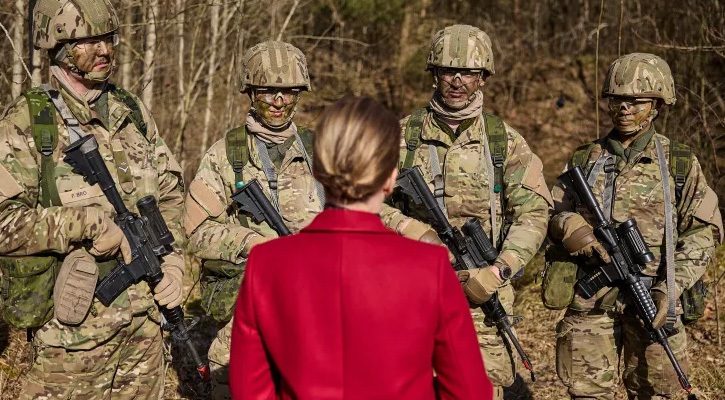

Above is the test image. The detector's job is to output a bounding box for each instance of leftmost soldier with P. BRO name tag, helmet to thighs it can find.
[0,0,184,399]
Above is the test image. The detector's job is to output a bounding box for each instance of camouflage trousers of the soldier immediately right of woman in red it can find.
[471,283,516,400]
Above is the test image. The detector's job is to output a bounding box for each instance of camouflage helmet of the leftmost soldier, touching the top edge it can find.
[33,0,118,50]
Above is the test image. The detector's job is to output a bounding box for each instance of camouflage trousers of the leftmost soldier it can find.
[20,315,166,400]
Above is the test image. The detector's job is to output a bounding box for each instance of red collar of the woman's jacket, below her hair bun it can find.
[302,208,395,234]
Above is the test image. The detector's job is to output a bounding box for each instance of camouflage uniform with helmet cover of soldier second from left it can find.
[185,42,323,399]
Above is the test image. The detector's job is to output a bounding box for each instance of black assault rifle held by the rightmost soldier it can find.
[559,166,697,399]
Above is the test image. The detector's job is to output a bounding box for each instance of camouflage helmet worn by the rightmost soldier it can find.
[602,53,677,105]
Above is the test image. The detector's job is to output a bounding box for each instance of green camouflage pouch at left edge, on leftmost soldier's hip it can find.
[0,256,60,329]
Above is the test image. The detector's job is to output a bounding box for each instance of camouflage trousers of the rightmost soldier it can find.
[556,308,689,400]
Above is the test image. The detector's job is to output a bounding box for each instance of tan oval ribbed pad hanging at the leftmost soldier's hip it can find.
[53,249,98,325]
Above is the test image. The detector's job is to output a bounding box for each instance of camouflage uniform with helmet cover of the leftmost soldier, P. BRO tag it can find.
[0,0,183,399]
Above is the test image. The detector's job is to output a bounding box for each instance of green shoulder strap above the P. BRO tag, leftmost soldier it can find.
[23,87,61,208]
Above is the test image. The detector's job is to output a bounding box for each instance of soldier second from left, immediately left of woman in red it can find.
[184,41,324,399]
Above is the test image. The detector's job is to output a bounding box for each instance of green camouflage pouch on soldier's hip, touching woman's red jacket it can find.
[201,260,246,322]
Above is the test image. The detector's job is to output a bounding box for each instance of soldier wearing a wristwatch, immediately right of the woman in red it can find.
[383,25,551,399]
